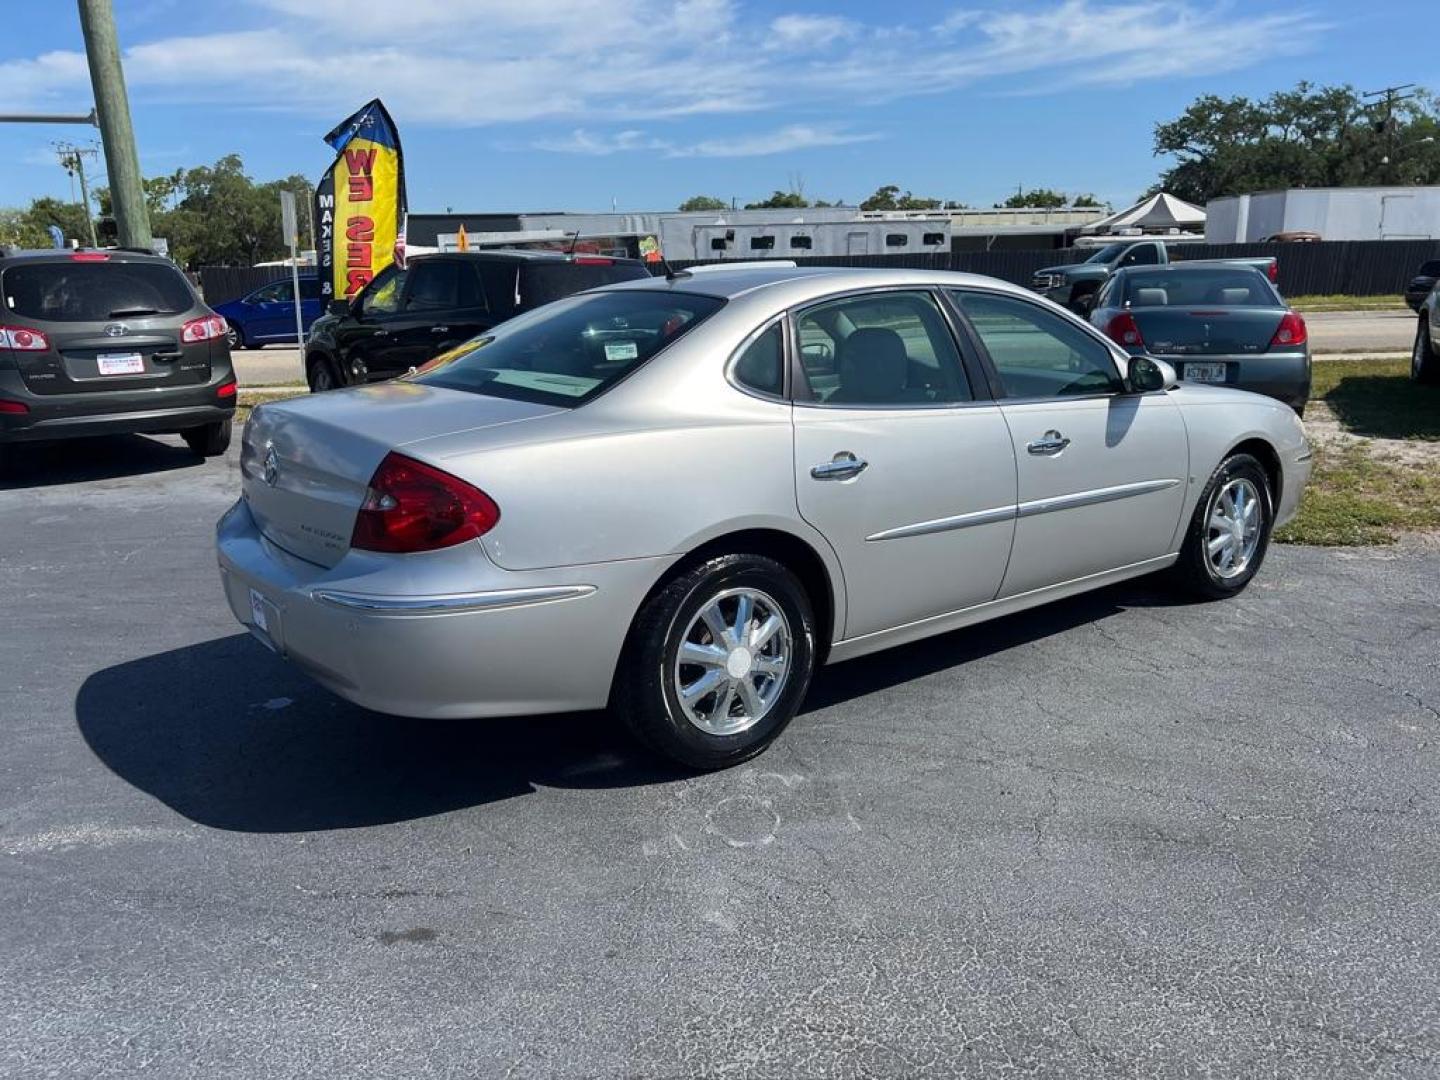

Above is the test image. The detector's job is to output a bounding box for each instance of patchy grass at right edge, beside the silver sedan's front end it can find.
[1274,360,1440,546]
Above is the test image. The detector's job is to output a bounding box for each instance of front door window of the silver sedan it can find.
[950,292,1123,397]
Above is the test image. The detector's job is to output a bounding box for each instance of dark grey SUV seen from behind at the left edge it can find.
[0,251,235,466]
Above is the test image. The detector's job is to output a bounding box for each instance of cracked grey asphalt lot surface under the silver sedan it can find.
[0,439,1440,1080]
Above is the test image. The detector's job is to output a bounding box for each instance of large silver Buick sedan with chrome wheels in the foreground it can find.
[217,266,1310,769]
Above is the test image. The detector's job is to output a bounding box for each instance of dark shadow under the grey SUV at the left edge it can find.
[0,435,204,491]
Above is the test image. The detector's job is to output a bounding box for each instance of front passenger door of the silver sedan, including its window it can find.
[949,289,1189,596]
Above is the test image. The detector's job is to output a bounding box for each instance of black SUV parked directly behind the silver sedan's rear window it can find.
[305,251,649,390]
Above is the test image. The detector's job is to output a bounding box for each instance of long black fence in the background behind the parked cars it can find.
[671,240,1440,297]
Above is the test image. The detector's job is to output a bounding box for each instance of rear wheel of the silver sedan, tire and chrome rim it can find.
[611,554,815,769]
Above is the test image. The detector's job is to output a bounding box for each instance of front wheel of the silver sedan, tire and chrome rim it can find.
[1175,454,1274,600]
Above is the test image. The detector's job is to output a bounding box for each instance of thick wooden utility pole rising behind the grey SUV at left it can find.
[79,0,154,248]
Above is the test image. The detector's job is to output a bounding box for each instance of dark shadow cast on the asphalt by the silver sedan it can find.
[75,582,1185,832]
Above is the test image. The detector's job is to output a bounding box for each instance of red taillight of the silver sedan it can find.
[350,452,500,553]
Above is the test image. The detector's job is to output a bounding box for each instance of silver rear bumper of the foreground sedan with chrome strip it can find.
[216,500,667,719]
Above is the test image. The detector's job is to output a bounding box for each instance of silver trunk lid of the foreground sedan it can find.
[240,382,560,567]
